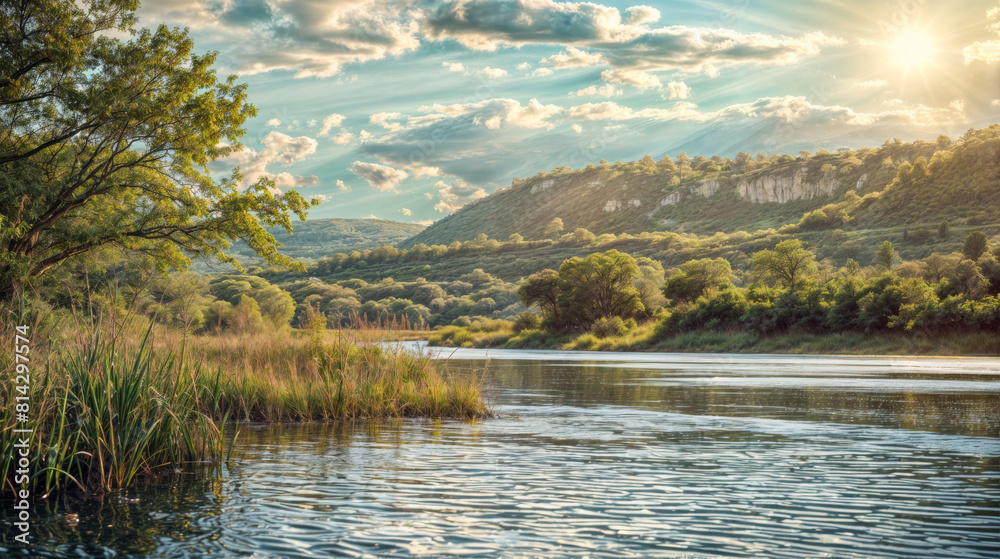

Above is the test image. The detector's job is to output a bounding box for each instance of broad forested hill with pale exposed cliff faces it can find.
[399,125,1000,248]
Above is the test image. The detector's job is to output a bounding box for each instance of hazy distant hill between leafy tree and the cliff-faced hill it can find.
[233,219,425,263]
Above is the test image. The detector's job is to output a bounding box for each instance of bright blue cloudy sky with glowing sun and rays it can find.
[139,0,1000,224]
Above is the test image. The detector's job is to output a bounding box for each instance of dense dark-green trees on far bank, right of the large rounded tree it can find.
[658,233,1000,335]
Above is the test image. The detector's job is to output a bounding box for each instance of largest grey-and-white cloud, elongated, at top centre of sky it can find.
[423,0,845,80]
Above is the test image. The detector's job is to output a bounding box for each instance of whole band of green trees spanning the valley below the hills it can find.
[27,224,1000,337]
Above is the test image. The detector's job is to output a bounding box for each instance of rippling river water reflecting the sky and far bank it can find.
[0,344,1000,558]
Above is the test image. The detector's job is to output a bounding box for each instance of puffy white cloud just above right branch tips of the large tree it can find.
[219,130,319,191]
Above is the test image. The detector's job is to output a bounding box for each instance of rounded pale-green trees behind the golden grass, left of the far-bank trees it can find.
[128,268,528,333]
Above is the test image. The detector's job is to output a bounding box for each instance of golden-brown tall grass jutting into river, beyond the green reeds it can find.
[173,330,489,421]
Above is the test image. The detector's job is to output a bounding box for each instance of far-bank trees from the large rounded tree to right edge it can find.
[518,231,1000,339]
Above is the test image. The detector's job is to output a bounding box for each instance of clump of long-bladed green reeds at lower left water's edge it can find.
[0,331,231,493]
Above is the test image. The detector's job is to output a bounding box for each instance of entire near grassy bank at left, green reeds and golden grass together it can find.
[0,312,490,496]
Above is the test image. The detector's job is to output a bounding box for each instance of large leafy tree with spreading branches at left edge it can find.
[0,0,310,298]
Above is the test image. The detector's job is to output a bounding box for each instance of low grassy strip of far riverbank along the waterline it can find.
[428,324,1000,356]
